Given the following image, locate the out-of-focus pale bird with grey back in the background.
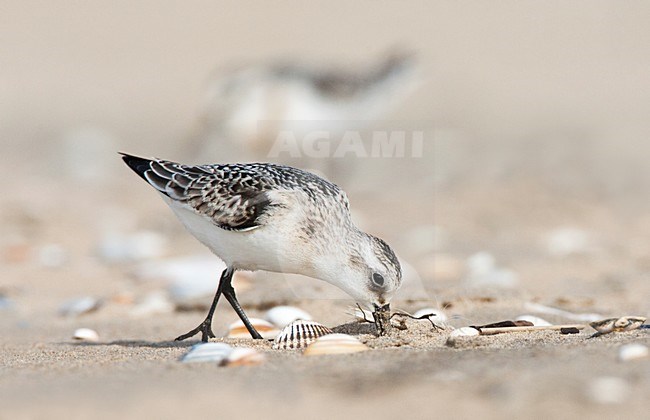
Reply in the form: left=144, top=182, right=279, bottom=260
left=192, top=50, right=418, bottom=157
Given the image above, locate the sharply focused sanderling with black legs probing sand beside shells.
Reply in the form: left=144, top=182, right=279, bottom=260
left=122, top=154, right=402, bottom=341
